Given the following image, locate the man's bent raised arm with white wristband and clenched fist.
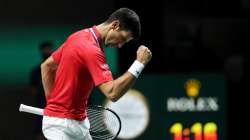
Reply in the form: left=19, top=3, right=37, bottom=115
left=99, top=46, right=152, bottom=102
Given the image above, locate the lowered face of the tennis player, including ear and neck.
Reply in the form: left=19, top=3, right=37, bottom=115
left=105, top=23, right=133, bottom=48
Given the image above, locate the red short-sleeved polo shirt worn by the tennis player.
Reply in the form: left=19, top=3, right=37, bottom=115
left=44, top=26, right=113, bottom=120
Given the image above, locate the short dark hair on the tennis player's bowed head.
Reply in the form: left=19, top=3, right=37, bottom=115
left=105, top=8, right=141, bottom=40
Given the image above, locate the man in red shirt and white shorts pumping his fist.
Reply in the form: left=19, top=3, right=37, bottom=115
left=41, top=8, right=152, bottom=140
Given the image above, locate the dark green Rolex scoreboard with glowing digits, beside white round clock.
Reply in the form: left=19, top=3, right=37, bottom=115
left=135, top=73, right=227, bottom=140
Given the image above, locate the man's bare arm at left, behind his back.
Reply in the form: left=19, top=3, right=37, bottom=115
left=41, top=65, right=56, bottom=96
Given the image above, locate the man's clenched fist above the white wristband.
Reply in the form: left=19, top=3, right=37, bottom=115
left=136, top=45, right=152, bottom=65
